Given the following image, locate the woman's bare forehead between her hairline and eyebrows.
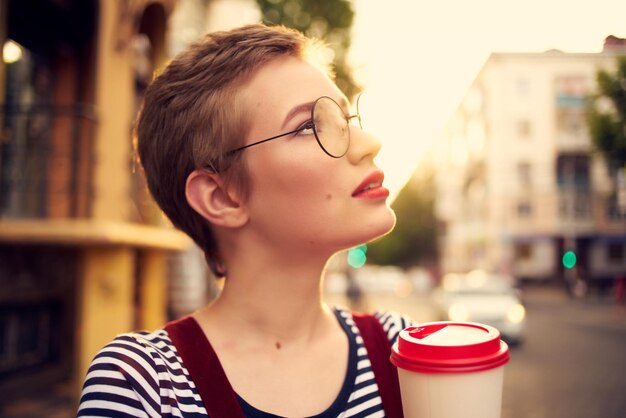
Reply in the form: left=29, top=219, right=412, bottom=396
left=241, top=56, right=345, bottom=122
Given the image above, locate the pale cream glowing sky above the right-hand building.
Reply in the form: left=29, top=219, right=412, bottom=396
left=350, top=0, right=626, bottom=196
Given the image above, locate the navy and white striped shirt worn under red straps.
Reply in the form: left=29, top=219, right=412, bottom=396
left=78, top=308, right=410, bottom=418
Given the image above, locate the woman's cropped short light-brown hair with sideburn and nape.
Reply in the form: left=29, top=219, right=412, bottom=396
left=136, top=24, right=316, bottom=276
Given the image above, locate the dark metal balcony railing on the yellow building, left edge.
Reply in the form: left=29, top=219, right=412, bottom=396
left=0, top=103, right=96, bottom=218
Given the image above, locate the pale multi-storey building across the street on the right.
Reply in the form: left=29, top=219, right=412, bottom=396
left=436, top=38, right=626, bottom=292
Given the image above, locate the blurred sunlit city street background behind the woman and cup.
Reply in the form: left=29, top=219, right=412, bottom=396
left=0, top=0, right=626, bottom=418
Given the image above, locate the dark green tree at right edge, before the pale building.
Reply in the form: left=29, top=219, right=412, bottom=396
left=588, top=57, right=626, bottom=167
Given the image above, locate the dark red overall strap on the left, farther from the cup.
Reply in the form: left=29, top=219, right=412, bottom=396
left=165, top=316, right=245, bottom=418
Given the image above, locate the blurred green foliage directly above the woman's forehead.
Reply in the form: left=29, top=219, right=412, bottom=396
left=257, top=0, right=359, bottom=98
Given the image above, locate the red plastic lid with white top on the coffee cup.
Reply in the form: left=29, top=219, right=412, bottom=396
left=391, top=322, right=509, bottom=373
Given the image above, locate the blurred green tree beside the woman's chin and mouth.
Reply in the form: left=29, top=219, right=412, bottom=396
left=367, top=170, right=438, bottom=267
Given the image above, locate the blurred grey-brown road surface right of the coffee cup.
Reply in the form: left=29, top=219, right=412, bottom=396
left=502, top=288, right=626, bottom=418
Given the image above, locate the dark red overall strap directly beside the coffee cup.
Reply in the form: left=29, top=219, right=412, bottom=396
left=352, top=312, right=404, bottom=418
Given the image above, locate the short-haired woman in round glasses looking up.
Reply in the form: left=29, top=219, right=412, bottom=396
left=79, top=25, right=408, bottom=418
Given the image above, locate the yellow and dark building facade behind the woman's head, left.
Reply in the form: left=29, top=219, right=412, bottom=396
left=0, top=0, right=190, bottom=406
